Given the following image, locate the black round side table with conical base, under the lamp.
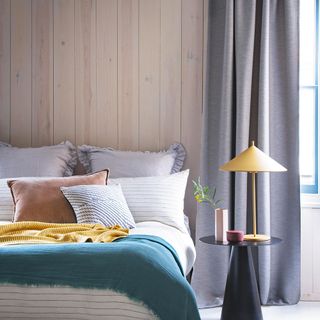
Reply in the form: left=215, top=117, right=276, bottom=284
left=200, top=236, right=282, bottom=320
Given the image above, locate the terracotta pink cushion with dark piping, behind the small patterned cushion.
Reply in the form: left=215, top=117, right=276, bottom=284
left=8, top=170, right=109, bottom=223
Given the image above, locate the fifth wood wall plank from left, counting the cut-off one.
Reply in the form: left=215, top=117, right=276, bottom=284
left=75, top=0, right=97, bottom=145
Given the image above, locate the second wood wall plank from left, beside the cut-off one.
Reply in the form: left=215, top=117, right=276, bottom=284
left=10, top=0, right=31, bottom=146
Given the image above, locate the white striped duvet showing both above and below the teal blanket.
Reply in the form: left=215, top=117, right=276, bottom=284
left=0, top=222, right=195, bottom=320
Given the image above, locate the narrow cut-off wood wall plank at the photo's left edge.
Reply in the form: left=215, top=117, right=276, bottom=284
left=0, top=0, right=11, bottom=142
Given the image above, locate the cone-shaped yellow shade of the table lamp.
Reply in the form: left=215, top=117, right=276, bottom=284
left=219, top=141, right=287, bottom=172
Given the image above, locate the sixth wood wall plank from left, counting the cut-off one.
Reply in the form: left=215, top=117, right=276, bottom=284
left=97, top=0, right=118, bottom=148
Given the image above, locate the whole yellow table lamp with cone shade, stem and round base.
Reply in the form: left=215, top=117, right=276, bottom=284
left=219, top=141, right=287, bottom=241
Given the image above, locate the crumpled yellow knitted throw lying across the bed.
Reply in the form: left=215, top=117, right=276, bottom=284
left=0, top=221, right=129, bottom=245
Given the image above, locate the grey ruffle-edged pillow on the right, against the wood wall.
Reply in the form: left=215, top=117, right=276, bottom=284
left=78, top=143, right=186, bottom=178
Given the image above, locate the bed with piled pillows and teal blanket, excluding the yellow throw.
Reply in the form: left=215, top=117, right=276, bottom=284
left=0, top=142, right=200, bottom=320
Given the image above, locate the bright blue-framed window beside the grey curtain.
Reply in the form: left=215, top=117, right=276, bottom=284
left=299, top=0, right=319, bottom=193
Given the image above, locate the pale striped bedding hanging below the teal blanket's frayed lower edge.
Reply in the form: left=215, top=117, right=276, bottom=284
left=0, top=284, right=157, bottom=320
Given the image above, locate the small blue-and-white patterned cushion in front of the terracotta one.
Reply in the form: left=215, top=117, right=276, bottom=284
left=60, top=185, right=135, bottom=228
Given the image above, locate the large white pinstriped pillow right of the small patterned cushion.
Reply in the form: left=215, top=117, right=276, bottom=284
left=108, top=170, right=189, bottom=230
